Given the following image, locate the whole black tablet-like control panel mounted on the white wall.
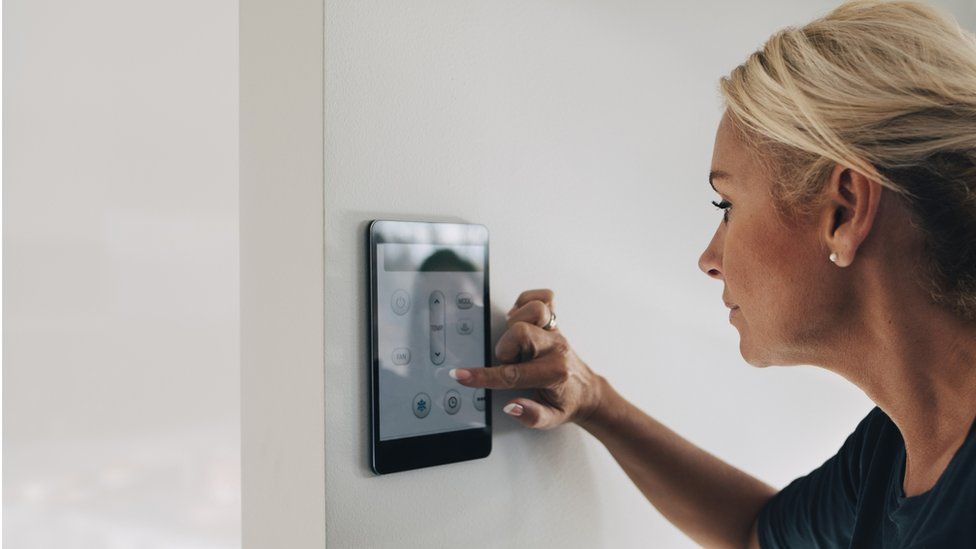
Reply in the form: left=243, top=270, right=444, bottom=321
left=368, top=220, right=491, bottom=474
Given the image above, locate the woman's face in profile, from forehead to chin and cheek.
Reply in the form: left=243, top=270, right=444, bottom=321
left=698, top=114, right=843, bottom=366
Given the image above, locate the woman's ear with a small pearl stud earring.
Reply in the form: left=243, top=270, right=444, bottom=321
left=822, top=164, right=884, bottom=267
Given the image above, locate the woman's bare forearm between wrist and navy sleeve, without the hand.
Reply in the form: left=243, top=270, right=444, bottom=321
left=576, top=376, right=776, bottom=548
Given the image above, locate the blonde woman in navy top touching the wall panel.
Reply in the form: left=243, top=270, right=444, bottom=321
left=452, top=1, right=976, bottom=547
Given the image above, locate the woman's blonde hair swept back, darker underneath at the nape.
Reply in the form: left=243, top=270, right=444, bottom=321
left=720, top=0, right=976, bottom=320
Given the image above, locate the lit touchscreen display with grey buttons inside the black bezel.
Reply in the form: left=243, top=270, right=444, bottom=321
left=376, top=243, right=487, bottom=440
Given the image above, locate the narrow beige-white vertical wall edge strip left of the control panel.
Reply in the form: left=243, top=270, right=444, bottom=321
left=240, top=0, right=325, bottom=549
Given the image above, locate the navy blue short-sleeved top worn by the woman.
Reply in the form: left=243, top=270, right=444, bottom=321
left=759, top=407, right=976, bottom=549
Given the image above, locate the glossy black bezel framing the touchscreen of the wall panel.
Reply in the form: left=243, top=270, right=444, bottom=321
left=366, top=219, right=492, bottom=475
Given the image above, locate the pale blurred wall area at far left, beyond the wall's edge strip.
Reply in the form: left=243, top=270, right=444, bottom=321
left=3, top=0, right=241, bottom=549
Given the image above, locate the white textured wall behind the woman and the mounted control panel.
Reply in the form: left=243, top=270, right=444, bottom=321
left=325, top=0, right=972, bottom=548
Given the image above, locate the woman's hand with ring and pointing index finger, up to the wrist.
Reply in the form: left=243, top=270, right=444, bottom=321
left=451, top=290, right=603, bottom=429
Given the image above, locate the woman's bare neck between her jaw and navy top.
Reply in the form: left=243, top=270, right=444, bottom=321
left=825, top=288, right=976, bottom=496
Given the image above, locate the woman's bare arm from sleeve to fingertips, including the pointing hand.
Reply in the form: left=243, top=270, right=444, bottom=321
left=458, top=289, right=776, bottom=548
